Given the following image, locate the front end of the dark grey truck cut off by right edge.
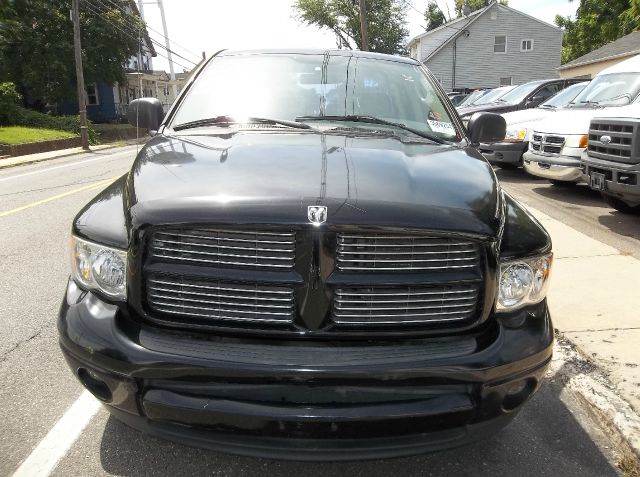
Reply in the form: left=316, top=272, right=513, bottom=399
left=582, top=118, right=640, bottom=213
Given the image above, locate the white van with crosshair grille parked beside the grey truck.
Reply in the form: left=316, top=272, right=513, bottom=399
left=523, top=55, right=640, bottom=185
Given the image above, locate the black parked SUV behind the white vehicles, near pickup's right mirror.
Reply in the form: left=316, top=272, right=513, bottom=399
left=458, top=79, right=583, bottom=120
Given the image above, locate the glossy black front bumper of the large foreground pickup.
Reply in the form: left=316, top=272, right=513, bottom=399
left=58, top=281, right=553, bottom=460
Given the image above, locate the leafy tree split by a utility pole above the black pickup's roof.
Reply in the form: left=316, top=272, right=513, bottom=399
left=294, top=0, right=409, bottom=54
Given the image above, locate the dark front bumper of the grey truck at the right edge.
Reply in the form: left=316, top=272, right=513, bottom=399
left=582, top=157, right=640, bottom=206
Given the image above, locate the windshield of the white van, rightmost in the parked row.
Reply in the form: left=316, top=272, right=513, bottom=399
left=571, top=73, right=640, bottom=107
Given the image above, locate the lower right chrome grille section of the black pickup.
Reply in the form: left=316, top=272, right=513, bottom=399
left=332, top=283, right=480, bottom=326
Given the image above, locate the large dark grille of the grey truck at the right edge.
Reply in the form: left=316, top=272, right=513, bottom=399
left=587, top=119, right=640, bottom=164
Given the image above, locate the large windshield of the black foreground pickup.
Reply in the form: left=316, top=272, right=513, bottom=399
left=172, top=53, right=459, bottom=140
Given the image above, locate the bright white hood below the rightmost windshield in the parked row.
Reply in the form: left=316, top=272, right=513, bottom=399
left=533, top=104, right=640, bottom=136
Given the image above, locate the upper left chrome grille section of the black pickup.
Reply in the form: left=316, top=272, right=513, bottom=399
left=151, top=228, right=295, bottom=270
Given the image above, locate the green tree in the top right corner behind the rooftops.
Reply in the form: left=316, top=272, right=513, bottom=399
left=555, top=0, right=640, bottom=63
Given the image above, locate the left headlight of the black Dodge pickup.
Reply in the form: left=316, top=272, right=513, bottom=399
left=71, top=236, right=127, bottom=300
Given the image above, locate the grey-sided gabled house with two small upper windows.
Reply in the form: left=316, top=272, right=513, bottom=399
left=408, top=2, right=562, bottom=91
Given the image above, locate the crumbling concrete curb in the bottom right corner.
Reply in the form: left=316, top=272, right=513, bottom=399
left=549, top=330, right=640, bottom=477
